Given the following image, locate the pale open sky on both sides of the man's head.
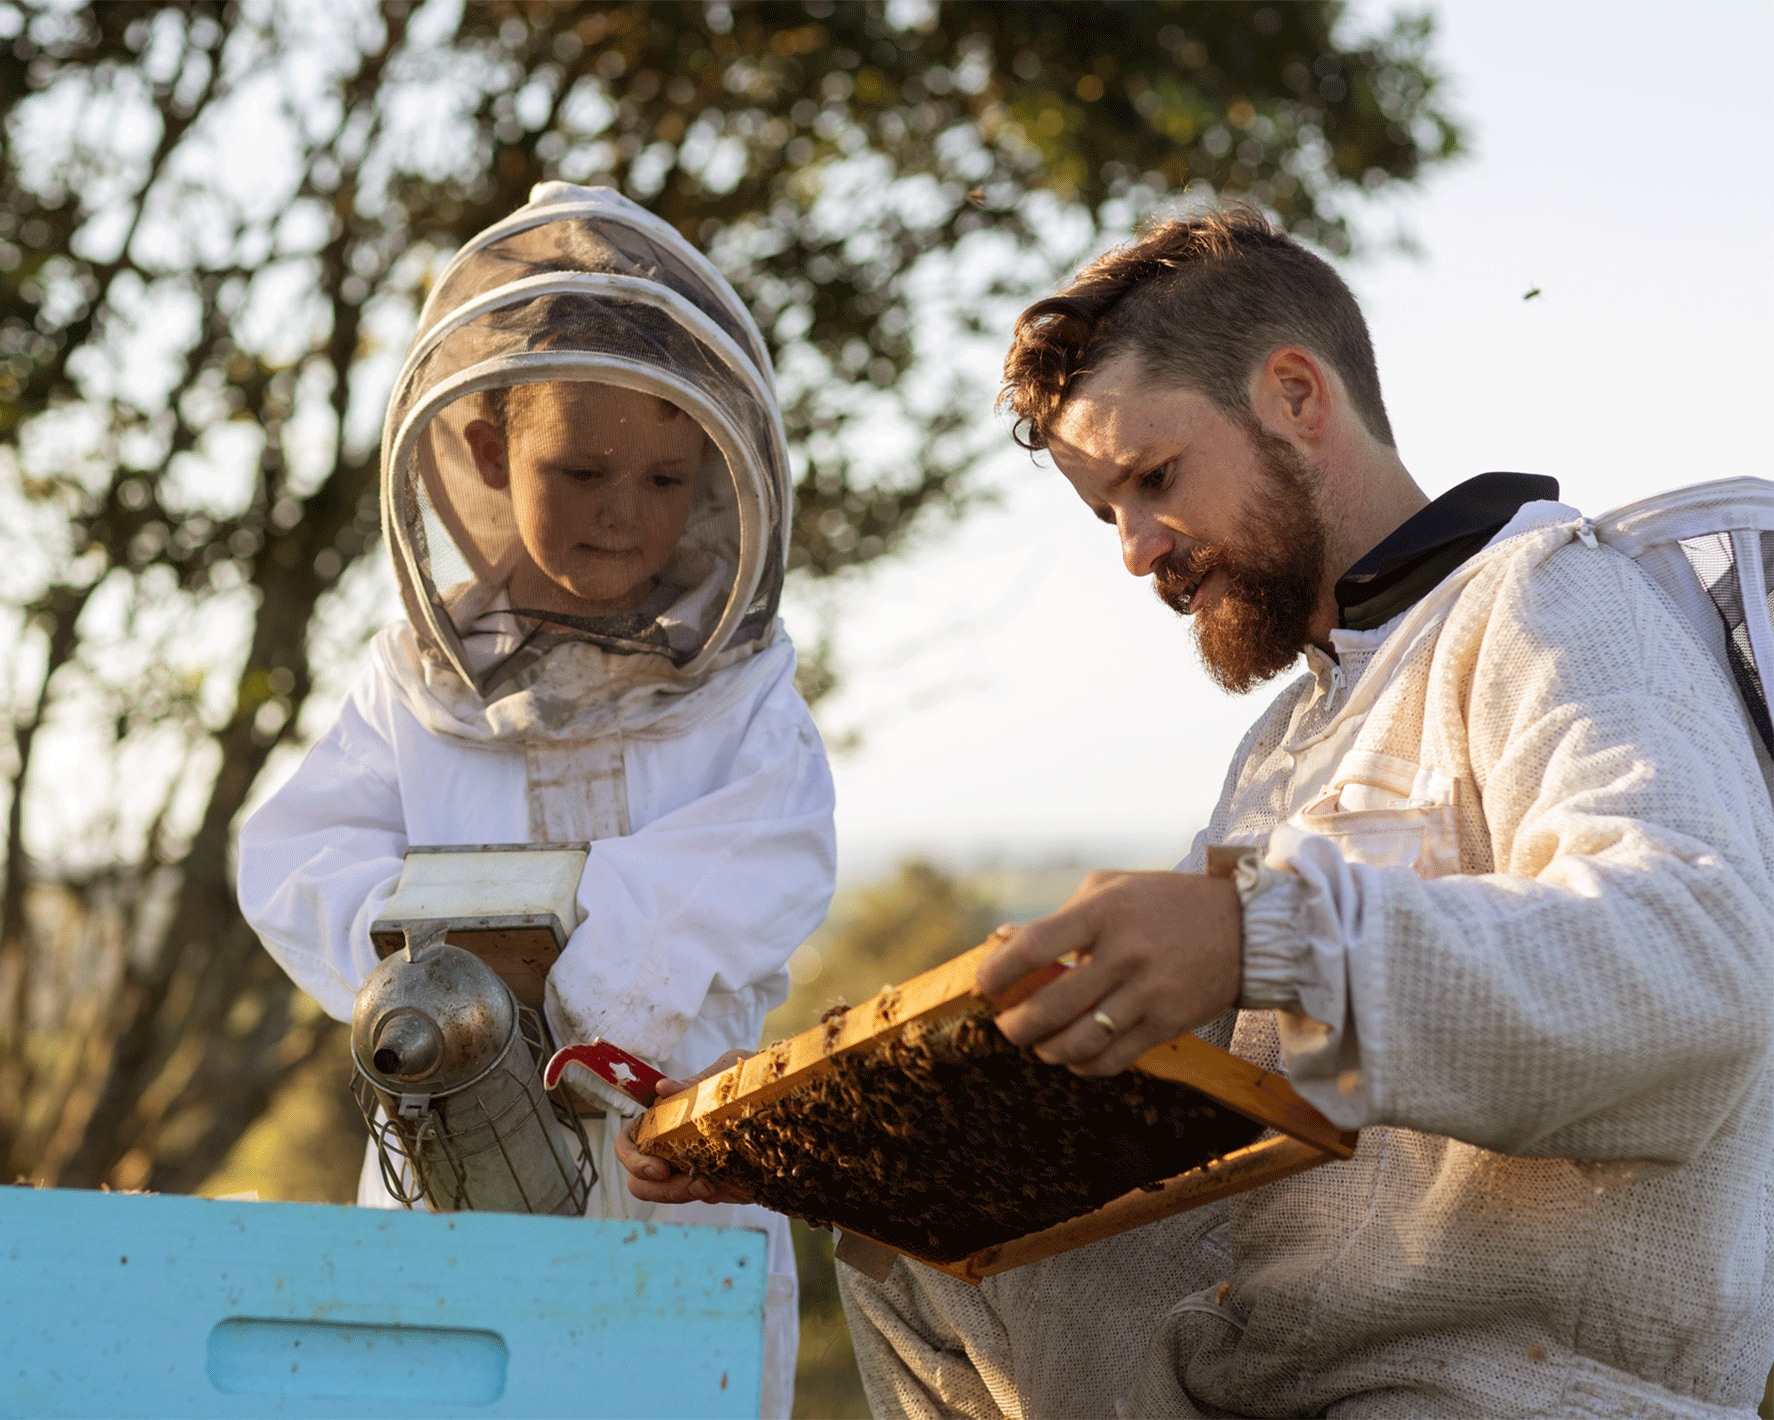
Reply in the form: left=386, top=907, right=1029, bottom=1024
left=805, top=0, right=1774, bottom=879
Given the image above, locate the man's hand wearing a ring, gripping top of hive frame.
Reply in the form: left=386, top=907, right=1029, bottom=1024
left=979, top=873, right=1244, bottom=1076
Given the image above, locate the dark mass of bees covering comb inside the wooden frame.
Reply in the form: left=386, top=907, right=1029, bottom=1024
left=676, top=1010, right=1263, bottom=1262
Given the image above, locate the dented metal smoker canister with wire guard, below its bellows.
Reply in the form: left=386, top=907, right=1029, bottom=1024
left=351, top=927, right=598, bottom=1216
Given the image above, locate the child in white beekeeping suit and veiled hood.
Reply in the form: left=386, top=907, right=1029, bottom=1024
left=239, top=183, right=836, bottom=1415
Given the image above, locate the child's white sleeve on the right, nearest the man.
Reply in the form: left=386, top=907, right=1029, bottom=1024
left=548, top=678, right=837, bottom=1061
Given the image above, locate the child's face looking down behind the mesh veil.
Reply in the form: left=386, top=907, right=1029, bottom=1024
left=467, top=382, right=704, bottom=616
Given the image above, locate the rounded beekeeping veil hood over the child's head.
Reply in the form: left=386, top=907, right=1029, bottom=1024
left=381, top=183, right=789, bottom=703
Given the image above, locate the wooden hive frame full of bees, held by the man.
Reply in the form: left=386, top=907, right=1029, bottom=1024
left=635, top=937, right=1355, bottom=1282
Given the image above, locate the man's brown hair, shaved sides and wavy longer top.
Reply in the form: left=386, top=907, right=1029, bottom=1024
left=999, top=206, right=1393, bottom=449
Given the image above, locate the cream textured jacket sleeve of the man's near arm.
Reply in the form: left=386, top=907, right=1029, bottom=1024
left=1245, top=559, right=1774, bottom=1163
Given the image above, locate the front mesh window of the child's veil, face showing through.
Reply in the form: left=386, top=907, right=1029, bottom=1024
left=404, top=380, right=740, bottom=683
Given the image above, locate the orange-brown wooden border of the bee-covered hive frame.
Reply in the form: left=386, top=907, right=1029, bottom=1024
left=635, top=861, right=1357, bottom=1283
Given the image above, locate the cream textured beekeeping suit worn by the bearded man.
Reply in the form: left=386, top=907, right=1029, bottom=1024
left=839, top=479, right=1774, bottom=1420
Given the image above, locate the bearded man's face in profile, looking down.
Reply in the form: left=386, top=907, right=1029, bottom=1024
left=1048, top=355, right=1325, bottom=692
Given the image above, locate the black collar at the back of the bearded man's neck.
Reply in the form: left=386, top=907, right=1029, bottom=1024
left=1336, top=474, right=1558, bottom=630
